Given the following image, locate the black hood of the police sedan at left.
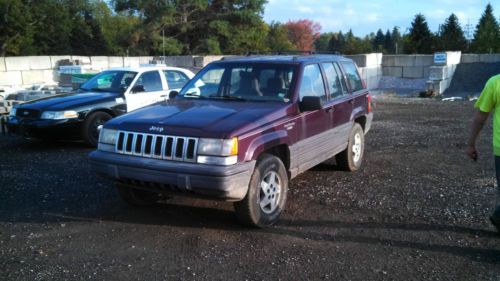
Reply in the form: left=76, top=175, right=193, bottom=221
left=19, top=92, right=120, bottom=110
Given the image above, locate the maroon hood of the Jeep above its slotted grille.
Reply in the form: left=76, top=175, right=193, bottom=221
left=106, top=99, right=290, bottom=138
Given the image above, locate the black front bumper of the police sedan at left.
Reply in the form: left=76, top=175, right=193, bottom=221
left=7, top=117, right=83, bottom=139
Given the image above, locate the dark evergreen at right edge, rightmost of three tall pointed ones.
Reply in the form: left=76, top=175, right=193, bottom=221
left=471, top=4, right=500, bottom=53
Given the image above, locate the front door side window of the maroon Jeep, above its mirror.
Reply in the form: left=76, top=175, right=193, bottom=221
left=299, top=64, right=326, bottom=101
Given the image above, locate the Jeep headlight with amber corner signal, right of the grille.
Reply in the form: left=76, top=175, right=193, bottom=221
left=197, top=137, right=238, bottom=166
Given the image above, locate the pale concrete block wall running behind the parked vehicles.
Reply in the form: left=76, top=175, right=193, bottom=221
left=0, top=53, right=500, bottom=89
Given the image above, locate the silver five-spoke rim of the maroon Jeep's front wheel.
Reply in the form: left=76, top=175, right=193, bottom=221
left=259, top=171, right=281, bottom=214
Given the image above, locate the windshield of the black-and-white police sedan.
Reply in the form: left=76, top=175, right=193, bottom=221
left=80, top=70, right=137, bottom=93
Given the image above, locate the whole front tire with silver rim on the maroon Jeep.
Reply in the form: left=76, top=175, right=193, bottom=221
left=234, top=154, right=288, bottom=227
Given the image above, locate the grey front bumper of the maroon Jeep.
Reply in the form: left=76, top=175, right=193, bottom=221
left=89, top=150, right=255, bottom=201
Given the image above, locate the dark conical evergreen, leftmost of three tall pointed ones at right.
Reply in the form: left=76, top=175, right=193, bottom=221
left=404, top=14, right=434, bottom=54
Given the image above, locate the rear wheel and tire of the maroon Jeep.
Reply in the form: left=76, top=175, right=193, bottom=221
left=335, top=123, right=365, bottom=172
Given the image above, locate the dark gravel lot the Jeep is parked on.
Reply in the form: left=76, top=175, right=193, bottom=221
left=0, top=99, right=500, bottom=280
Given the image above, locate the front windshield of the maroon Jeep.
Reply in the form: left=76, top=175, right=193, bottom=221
left=179, top=63, right=296, bottom=103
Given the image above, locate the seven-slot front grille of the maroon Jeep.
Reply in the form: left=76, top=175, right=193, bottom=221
left=115, top=131, right=198, bottom=162
